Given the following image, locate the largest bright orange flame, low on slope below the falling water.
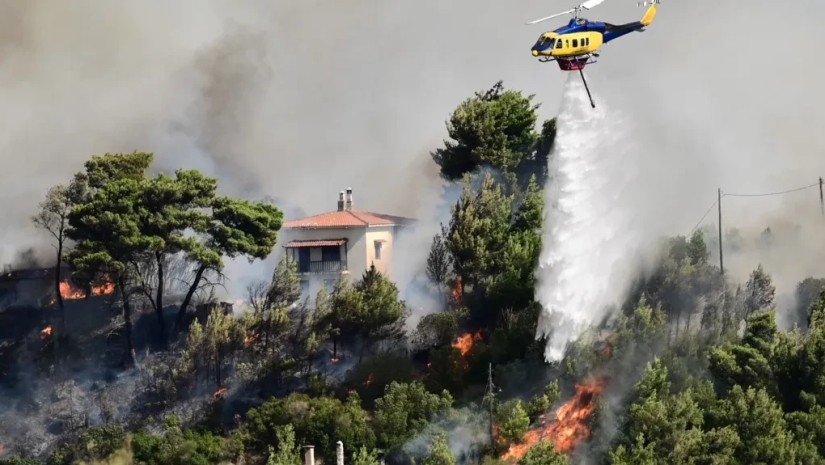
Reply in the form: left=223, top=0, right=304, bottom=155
left=502, top=378, right=606, bottom=461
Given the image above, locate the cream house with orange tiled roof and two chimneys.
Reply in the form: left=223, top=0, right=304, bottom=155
left=282, top=188, right=415, bottom=298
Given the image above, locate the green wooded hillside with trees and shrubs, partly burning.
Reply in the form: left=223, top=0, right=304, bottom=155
left=0, top=83, right=825, bottom=465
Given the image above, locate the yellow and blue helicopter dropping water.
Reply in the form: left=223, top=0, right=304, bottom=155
left=527, top=0, right=662, bottom=108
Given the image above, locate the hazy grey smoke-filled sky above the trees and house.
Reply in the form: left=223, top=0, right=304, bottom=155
left=0, top=0, right=825, bottom=296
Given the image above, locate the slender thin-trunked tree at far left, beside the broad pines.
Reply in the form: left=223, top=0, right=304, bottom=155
left=32, top=181, right=82, bottom=332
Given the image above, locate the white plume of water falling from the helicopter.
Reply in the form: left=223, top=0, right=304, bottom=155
left=536, top=73, right=643, bottom=362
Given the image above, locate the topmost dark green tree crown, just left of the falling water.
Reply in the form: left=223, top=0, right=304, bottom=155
left=431, top=81, right=539, bottom=180
